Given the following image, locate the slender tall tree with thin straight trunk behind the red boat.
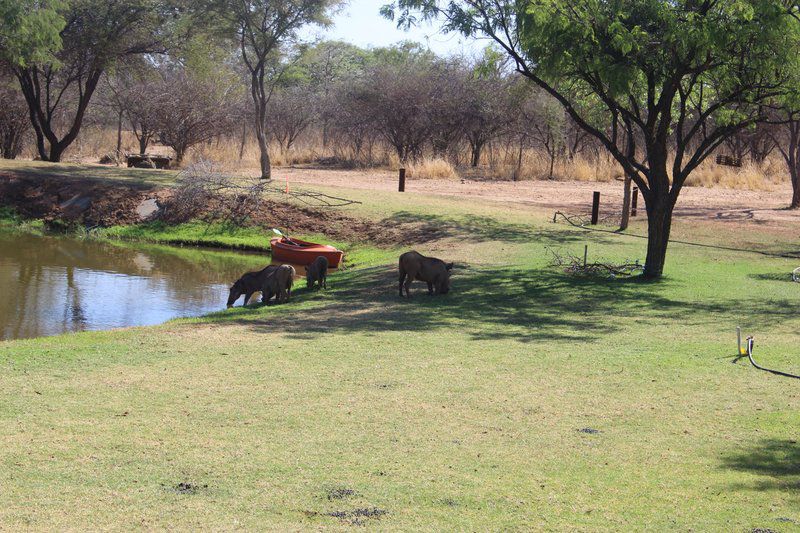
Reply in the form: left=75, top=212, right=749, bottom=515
left=211, top=0, right=339, bottom=179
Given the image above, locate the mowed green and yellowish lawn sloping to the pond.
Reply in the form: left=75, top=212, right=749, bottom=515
left=0, top=162, right=800, bottom=531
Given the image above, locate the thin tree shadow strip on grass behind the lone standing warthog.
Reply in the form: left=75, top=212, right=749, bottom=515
left=380, top=211, right=616, bottom=245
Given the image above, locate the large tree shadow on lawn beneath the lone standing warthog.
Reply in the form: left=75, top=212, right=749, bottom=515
left=209, top=267, right=795, bottom=342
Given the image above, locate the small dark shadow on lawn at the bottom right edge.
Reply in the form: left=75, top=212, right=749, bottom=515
left=722, top=439, right=800, bottom=497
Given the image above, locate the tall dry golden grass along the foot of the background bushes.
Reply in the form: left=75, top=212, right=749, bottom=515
left=29, top=125, right=787, bottom=191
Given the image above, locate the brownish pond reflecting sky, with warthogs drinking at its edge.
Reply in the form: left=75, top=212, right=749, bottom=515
left=0, top=232, right=269, bottom=340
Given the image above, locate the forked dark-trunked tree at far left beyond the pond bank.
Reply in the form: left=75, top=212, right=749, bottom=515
left=0, top=0, right=177, bottom=161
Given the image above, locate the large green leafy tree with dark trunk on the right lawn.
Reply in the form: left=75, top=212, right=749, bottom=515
left=382, top=0, right=800, bottom=278
